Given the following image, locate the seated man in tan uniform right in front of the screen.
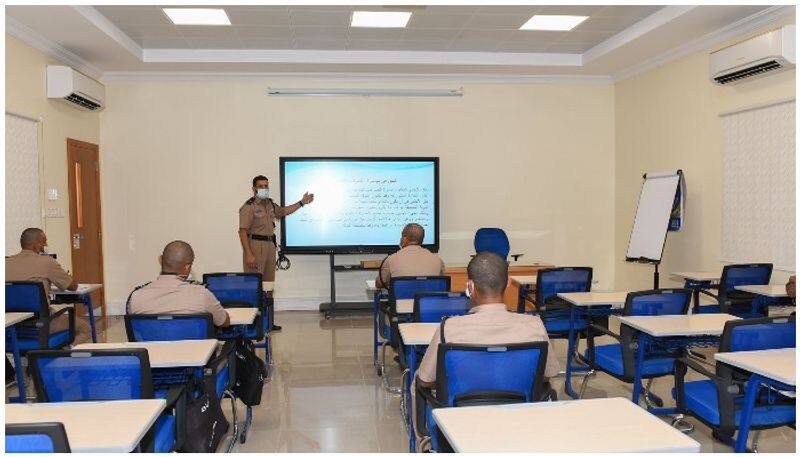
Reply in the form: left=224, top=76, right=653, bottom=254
left=375, top=223, right=444, bottom=288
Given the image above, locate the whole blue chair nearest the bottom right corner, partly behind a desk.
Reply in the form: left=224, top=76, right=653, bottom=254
left=672, top=315, right=797, bottom=447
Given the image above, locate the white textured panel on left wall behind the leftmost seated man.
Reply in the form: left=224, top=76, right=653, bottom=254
left=6, top=114, right=42, bottom=255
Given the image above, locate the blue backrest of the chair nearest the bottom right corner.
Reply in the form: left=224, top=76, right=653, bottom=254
left=719, top=316, right=797, bottom=352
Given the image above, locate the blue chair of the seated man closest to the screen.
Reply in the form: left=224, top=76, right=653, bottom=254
left=378, top=276, right=450, bottom=391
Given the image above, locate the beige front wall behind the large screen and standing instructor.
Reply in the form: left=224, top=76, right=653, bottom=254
left=101, top=80, right=614, bottom=312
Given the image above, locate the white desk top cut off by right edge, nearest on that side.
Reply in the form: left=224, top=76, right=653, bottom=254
left=714, top=348, right=797, bottom=386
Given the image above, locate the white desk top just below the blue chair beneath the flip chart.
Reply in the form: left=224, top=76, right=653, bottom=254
left=619, top=314, right=739, bottom=337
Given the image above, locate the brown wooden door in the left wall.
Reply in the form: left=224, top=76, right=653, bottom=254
left=67, top=138, right=106, bottom=323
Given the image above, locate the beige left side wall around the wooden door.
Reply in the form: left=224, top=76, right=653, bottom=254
left=6, top=34, right=104, bottom=268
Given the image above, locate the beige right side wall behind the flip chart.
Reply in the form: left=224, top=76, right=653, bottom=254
left=614, top=19, right=795, bottom=290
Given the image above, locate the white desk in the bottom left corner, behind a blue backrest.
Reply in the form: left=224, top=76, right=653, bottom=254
left=6, top=398, right=167, bottom=453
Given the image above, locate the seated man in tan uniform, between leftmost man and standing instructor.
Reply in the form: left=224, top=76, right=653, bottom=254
left=127, top=241, right=231, bottom=327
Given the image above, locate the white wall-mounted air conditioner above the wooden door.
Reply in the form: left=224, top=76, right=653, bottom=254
left=47, top=65, right=106, bottom=111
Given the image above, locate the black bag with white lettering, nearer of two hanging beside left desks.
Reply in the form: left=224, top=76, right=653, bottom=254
left=181, top=377, right=230, bottom=453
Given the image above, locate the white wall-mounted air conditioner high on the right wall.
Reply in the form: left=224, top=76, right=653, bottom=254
left=709, top=25, right=795, bottom=85
